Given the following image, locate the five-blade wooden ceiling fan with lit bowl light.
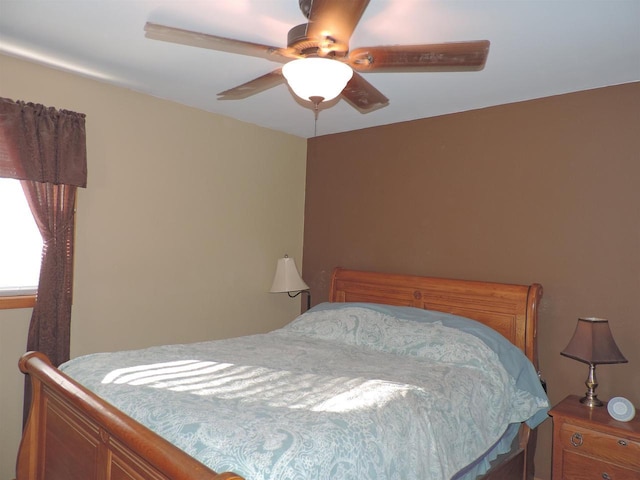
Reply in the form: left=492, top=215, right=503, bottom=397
left=144, top=0, right=489, bottom=113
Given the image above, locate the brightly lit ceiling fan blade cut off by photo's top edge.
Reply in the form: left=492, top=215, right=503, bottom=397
left=300, top=0, right=369, bottom=52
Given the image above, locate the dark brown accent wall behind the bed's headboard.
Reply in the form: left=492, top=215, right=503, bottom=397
left=304, top=83, right=640, bottom=479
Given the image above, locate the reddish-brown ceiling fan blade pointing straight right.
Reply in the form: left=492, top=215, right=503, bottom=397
left=349, top=40, right=489, bottom=72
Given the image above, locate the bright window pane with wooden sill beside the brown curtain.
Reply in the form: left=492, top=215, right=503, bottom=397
left=0, top=178, right=42, bottom=308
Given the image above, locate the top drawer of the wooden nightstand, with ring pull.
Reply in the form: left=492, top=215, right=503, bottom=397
left=560, top=423, right=640, bottom=468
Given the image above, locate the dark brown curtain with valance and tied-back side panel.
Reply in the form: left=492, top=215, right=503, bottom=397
left=0, top=98, right=87, bottom=419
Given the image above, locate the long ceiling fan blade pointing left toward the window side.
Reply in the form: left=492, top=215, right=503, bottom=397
left=144, top=22, right=299, bottom=63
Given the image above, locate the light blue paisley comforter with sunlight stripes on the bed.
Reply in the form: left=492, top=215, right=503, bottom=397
left=61, top=304, right=548, bottom=480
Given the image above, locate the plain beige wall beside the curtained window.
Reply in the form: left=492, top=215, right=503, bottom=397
left=0, top=56, right=306, bottom=480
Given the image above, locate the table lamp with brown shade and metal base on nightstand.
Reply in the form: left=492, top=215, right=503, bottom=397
left=560, top=318, right=628, bottom=407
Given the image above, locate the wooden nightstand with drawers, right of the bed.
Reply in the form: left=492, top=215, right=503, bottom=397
left=549, top=395, right=640, bottom=480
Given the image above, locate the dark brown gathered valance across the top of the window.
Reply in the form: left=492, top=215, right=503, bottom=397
left=0, top=97, right=87, bottom=187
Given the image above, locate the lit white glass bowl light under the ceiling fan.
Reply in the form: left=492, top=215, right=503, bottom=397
left=282, top=57, right=353, bottom=102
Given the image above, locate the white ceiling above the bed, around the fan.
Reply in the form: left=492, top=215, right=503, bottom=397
left=0, top=0, right=640, bottom=138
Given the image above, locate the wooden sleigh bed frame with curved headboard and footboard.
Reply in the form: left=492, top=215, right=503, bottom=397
left=16, top=268, right=542, bottom=480
